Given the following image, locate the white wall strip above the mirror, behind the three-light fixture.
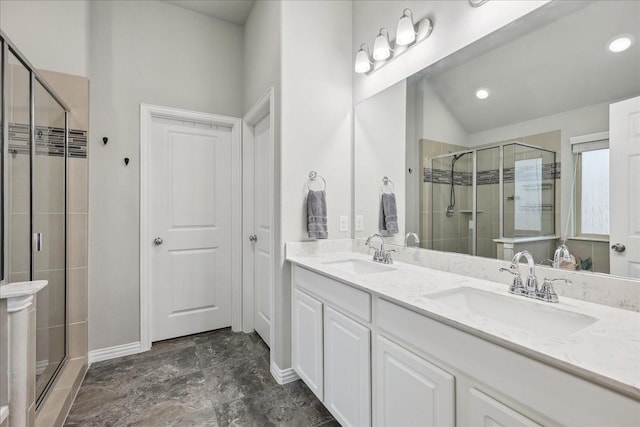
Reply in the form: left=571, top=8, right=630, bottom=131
left=350, top=0, right=549, bottom=104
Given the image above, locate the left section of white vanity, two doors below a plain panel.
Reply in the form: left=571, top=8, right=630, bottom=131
left=292, top=267, right=371, bottom=427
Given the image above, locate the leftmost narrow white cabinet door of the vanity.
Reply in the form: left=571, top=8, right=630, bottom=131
left=291, top=289, right=323, bottom=400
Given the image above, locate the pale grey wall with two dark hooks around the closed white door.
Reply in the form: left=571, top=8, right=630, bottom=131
left=89, top=0, right=243, bottom=350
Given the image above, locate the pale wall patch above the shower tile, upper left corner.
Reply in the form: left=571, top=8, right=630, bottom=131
left=0, top=0, right=89, bottom=77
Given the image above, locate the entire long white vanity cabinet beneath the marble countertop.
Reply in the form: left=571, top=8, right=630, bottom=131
left=292, top=265, right=640, bottom=427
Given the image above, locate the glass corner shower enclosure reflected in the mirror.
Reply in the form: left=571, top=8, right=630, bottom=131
left=421, top=143, right=556, bottom=258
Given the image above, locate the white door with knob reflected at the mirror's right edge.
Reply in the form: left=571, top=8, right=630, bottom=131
left=609, top=97, right=640, bottom=278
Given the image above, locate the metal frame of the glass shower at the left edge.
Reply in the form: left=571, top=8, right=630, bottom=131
left=0, top=30, right=71, bottom=410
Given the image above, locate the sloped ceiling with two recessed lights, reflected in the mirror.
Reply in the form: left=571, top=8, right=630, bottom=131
left=416, top=1, right=640, bottom=134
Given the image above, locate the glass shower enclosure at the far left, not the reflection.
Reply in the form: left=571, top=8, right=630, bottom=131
left=0, top=32, right=69, bottom=405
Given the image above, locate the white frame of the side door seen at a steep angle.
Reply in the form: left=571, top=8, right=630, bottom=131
left=242, top=87, right=276, bottom=346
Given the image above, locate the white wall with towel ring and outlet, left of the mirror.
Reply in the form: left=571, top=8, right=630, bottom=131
left=272, top=1, right=353, bottom=368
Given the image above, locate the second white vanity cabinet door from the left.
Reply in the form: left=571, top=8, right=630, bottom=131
left=324, top=307, right=371, bottom=427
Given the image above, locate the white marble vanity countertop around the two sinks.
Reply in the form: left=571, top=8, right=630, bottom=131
left=287, top=250, right=640, bottom=400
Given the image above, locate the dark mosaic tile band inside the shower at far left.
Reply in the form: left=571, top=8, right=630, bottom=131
left=9, top=123, right=87, bottom=159
